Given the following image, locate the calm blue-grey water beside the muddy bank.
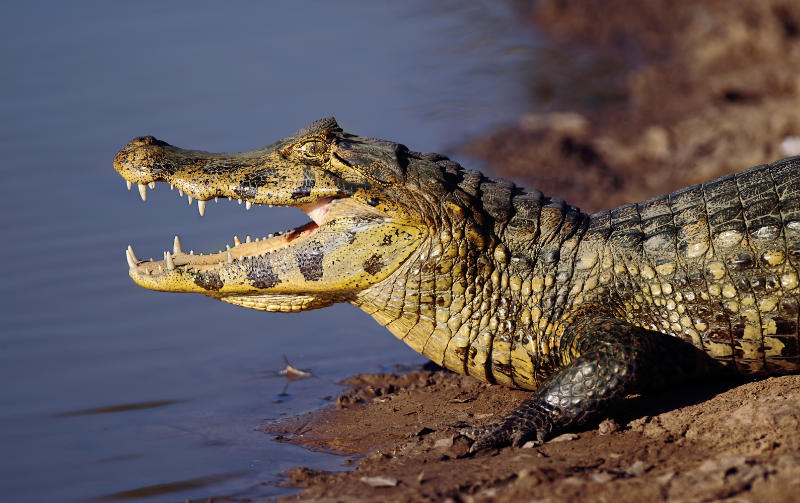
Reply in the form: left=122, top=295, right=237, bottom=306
left=0, top=0, right=544, bottom=502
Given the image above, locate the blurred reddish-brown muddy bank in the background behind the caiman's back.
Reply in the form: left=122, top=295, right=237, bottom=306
left=465, top=0, right=800, bottom=212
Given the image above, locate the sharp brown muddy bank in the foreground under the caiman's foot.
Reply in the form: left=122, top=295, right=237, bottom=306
left=267, top=371, right=800, bottom=502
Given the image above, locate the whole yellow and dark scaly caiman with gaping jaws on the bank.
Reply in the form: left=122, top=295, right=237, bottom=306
left=114, top=118, right=800, bottom=450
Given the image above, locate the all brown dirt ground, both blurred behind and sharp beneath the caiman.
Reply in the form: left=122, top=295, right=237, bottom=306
left=267, top=0, right=800, bottom=502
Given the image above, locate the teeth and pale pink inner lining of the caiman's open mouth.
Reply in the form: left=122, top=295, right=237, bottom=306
left=125, top=180, right=336, bottom=275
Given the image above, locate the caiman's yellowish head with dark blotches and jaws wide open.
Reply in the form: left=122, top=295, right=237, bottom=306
left=114, top=118, right=476, bottom=312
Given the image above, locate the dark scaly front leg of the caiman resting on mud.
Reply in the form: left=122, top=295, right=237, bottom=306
left=462, top=318, right=720, bottom=452
